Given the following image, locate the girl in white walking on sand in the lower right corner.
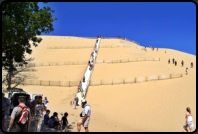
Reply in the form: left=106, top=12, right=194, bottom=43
left=183, top=107, right=194, bottom=132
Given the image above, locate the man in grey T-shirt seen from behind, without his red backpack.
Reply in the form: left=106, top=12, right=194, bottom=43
left=7, top=95, right=31, bottom=132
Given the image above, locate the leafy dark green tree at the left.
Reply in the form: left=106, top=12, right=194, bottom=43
left=2, top=2, right=57, bottom=89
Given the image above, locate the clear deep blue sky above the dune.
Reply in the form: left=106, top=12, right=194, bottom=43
left=38, top=2, right=196, bottom=55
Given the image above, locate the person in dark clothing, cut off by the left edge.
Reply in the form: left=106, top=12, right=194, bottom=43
left=2, top=93, right=11, bottom=132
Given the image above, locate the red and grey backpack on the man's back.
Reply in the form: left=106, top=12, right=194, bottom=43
left=15, top=105, right=30, bottom=125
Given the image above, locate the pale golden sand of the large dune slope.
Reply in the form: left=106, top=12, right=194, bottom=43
left=2, top=36, right=196, bottom=132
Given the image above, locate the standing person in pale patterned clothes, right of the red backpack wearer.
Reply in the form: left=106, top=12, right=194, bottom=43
left=34, top=98, right=44, bottom=132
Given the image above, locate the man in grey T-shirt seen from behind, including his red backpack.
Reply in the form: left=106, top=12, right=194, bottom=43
left=7, top=95, right=31, bottom=132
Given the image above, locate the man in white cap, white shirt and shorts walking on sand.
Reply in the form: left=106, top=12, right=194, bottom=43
left=77, top=99, right=91, bottom=132
